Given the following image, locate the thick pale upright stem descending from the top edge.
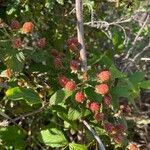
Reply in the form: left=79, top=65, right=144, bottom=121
left=75, top=0, right=87, bottom=73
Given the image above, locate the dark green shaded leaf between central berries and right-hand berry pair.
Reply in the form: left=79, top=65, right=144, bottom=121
left=85, top=87, right=102, bottom=103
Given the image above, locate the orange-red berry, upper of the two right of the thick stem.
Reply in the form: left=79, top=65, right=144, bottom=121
left=97, top=71, right=111, bottom=82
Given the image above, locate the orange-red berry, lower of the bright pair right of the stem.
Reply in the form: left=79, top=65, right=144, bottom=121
left=95, top=84, right=109, bottom=95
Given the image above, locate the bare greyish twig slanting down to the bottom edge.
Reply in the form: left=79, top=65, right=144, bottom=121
left=83, top=120, right=105, bottom=150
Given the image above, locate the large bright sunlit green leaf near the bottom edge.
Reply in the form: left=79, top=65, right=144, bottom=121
left=38, top=128, right=68, bottom=147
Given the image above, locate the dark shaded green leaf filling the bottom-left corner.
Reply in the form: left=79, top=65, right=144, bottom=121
left=0, top=126, right=26, bottom=150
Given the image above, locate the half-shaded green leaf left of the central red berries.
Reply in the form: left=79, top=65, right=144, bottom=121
left=50, top=89, right=72, bottom=105
